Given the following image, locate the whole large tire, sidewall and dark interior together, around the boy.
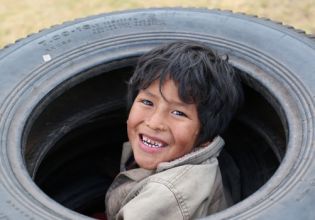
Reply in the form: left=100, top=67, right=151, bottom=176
left=0, top=9, right=315, bottom=220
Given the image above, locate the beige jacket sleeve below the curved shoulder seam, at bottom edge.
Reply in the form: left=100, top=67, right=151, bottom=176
left=116, top=182, right=189, bottom=220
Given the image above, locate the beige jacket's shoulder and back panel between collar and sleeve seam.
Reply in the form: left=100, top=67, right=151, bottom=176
left=145, top=161, right=222, bottom=218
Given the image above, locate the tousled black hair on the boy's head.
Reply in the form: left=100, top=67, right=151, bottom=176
left=127, top=41, right=243, bottom=146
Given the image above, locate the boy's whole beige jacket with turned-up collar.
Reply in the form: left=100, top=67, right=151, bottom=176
left=105, top=137, right=227, bottom=220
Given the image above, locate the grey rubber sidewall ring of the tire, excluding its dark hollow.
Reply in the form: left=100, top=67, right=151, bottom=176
left=0, top=8, right=315, bottom=219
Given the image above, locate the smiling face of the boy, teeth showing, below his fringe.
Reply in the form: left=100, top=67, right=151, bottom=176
left=127, top=79, right=200, bottom=169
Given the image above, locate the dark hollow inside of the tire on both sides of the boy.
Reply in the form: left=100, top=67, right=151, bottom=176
left=23, top=61, right=286, bottom=217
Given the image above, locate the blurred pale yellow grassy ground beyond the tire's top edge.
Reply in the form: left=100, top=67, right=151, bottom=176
left=0, top=0, right=315, bottom=48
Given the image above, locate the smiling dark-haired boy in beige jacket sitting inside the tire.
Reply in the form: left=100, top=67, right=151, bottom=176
left=105, top=41, right=242, bottom=219
